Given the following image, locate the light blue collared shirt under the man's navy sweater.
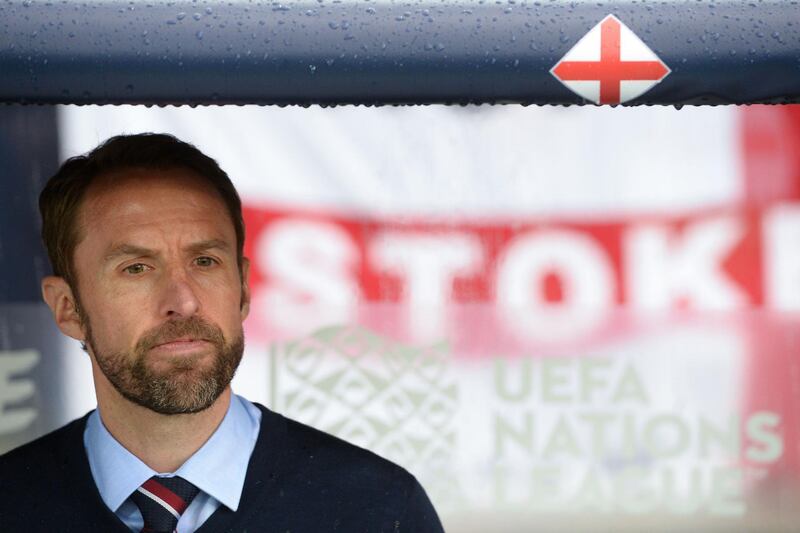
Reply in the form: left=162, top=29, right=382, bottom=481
left=83, top=394, right=261, bottom=533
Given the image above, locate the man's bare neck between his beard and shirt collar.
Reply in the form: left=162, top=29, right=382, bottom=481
left=95, top=366, right=231, bottom=473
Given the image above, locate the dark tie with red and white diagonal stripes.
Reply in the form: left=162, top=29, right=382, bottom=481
left=131, top=476, right=200, bottom=533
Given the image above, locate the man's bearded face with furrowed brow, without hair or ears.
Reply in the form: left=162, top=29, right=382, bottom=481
left=73, top=169, right=248, bottom=414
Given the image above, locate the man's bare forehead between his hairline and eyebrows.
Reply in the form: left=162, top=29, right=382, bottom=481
left=78, top=169, right=234, bottom=240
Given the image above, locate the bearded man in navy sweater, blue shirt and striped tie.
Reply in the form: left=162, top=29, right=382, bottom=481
left=0, top=134, right=442, bottom=533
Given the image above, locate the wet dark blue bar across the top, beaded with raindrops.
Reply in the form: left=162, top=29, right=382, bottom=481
left=0, top=0, right=800, bottom=105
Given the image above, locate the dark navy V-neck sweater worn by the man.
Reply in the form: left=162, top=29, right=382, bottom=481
left=0, top=405, right=442, bottom=533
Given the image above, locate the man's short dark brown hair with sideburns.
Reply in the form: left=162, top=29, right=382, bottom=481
left=39, top=133, right=244, bottom=289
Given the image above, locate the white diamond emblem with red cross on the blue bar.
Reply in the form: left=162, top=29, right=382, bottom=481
left=550, top=15, right=670, bottom=104
